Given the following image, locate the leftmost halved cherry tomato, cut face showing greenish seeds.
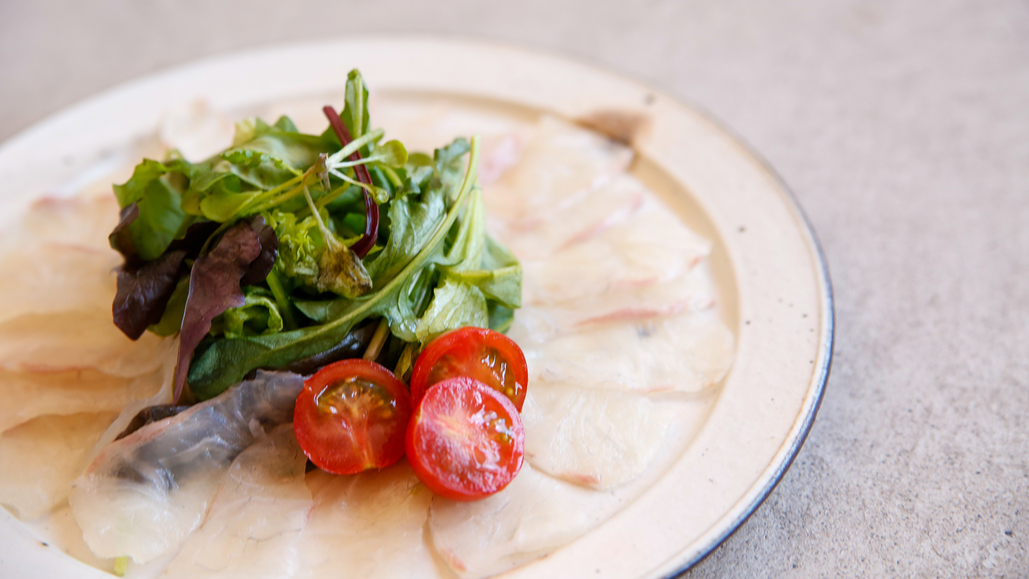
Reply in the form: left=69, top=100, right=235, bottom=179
left=293, top=358, right=411, bottom=474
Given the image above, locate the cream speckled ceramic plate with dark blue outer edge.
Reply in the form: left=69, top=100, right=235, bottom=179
left=0, top=37, right=832, bottom=578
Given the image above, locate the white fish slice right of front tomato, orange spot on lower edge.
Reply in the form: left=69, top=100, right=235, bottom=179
left=522, top=382, right=673, bottom=490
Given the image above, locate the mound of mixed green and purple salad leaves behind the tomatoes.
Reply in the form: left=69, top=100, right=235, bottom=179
left=110, top=70, right=522, bottom=400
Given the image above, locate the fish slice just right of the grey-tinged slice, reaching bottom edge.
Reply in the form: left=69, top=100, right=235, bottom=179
left=164, top=424, right=313, bottom=579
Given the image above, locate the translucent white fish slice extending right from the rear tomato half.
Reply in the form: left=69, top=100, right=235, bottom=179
left=509, top=310, right=735, bottom=392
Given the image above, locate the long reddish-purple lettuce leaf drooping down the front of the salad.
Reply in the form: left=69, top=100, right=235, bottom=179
left=174, top=216, right=278, bottom=401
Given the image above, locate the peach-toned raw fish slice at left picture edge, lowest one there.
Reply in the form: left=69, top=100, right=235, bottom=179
left=0, top=412, right=117, bottom=519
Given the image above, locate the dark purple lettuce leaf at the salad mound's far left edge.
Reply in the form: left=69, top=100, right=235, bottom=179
left=111, top=250, right=186, bottom=339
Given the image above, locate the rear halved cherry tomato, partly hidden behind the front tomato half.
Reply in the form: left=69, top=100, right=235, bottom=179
left=411, top=327, right=529, bottom=412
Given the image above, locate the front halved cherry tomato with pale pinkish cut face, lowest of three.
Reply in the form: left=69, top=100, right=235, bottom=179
left=406, top=377, right=525, bottom=501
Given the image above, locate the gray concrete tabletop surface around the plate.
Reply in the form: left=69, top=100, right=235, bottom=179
left=0, top=0, right=1029, bottom=579
